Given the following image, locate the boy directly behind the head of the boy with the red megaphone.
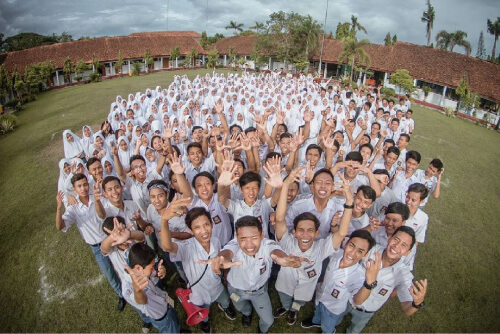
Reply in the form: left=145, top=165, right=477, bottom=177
left=190, top=172, right=232, bottom=246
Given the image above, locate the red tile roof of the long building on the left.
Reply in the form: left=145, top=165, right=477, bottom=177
left=0, top=32, right=205, bottom=73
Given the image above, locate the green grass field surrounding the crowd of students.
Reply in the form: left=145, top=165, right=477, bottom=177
left=0, top=71, right=500, bottom=332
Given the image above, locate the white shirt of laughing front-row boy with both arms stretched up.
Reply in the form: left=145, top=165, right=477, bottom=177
left=276, top=231, right=335, bottom=301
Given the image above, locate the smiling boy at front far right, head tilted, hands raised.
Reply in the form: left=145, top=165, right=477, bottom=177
left=347, top=226, right=427, bottom=333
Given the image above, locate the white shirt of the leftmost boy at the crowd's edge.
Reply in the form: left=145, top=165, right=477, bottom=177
left=62, top=197, right=106, bottom=245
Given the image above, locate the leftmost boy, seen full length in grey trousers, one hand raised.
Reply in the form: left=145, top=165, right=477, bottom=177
left=56, top=174, right=126, bottom=311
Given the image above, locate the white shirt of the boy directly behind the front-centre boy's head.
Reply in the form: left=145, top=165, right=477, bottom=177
left=226, top=198, right=274, bottom=238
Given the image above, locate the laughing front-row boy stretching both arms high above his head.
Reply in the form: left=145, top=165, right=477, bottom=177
left=273, top=167, right=353, bottom=326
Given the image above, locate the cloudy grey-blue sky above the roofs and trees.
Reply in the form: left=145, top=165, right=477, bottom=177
left=0, top=0, right=500, bottom=56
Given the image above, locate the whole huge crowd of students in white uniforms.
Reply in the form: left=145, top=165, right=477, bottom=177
left=56, top=72, right=444, bottom=333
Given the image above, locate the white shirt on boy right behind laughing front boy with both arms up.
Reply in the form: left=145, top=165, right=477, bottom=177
left=285, top=195, right=344, bottom=239
